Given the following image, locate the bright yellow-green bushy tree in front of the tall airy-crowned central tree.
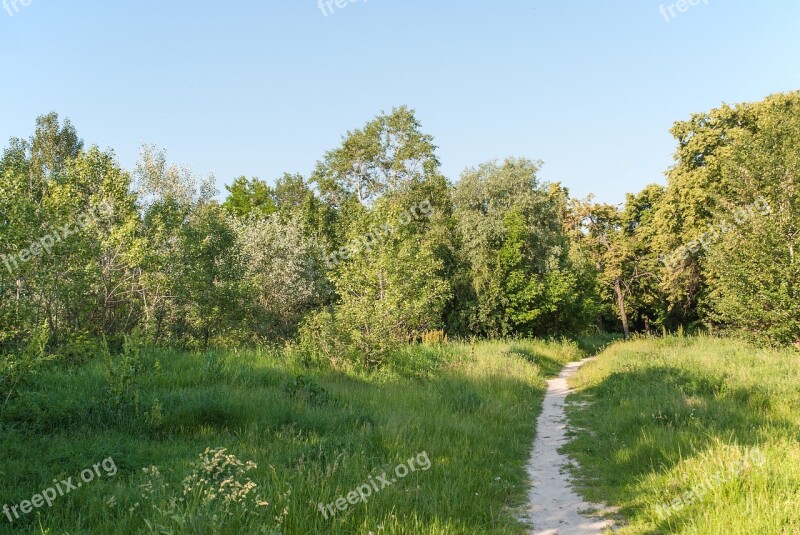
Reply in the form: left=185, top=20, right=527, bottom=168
left=304, top=196, right=450, bottom=367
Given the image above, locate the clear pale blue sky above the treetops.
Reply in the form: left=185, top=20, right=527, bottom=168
left=0, top=0, right=800, bottom=203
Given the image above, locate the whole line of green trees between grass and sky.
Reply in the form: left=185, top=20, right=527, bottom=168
left=0, top=92, right=800, bottom=366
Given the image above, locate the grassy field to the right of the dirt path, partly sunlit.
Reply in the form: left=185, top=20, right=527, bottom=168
left=567, top=337, right=800, bottom=535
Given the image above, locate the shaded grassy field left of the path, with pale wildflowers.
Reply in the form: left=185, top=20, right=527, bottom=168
left=0, top=341, right=582, bottom=535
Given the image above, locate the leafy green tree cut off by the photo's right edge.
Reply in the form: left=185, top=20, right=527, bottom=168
left=708, top=92, right=800, bottom=343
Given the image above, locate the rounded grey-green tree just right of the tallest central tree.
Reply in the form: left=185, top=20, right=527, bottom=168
left=453, top=159, right=580, bottom=335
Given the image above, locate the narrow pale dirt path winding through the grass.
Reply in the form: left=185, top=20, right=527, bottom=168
left=525, top=359, right=611, bottom=535
